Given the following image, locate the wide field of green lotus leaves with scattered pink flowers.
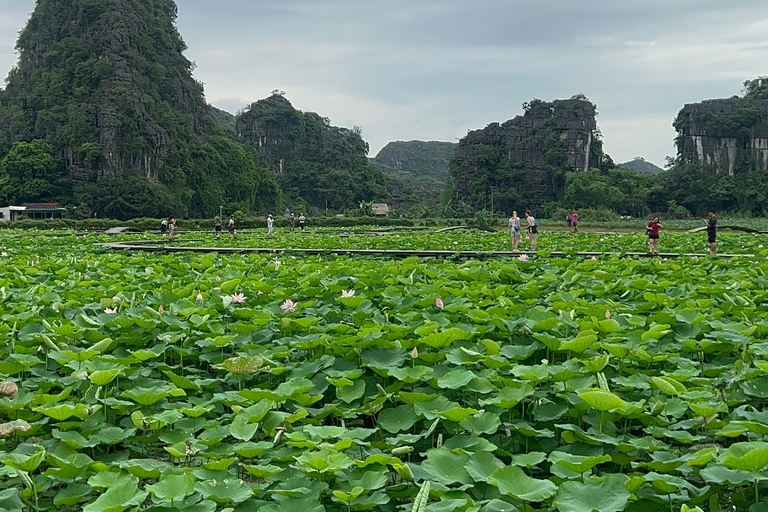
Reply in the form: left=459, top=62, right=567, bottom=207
left=0, top=232, right=768, bottom=512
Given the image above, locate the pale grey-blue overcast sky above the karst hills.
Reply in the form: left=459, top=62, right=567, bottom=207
left=0, top=0, right=768, bottom=165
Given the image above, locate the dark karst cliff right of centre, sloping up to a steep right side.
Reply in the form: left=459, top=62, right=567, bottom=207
left=451, top=98, right=610, bottom=210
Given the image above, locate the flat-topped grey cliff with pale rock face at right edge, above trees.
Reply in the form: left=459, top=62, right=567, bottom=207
left=675, top=96, right=768, bottom=176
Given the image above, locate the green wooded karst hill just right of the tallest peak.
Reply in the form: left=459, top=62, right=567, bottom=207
left=236, top=93, right=387, bottom=209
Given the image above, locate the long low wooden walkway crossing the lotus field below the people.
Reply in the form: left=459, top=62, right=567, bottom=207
left=103, top=240, right=755, bottom=259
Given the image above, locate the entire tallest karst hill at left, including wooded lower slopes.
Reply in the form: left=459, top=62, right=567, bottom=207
left=0, top=0, right=279, bottom=218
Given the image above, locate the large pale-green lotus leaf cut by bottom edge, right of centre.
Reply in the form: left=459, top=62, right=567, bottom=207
left=555, top=475, right=631, bottom=512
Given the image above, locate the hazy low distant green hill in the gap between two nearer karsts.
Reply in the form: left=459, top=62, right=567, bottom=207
left=371, top=140, right=456, bottom=206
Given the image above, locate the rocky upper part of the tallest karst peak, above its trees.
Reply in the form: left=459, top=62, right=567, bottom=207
left=0, top=0, right=214, bottom=181
